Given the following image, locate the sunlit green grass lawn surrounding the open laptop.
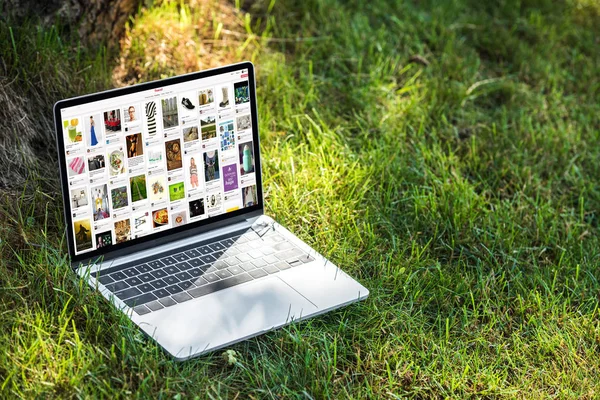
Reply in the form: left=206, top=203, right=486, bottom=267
left=0, top=0, right=600, bottom=398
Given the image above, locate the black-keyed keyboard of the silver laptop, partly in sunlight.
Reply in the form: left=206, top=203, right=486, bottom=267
left=96, top=229, right=314, bottom=315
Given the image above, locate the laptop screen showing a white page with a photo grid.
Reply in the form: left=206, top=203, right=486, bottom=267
left=55, top=64, right=262, bottom=258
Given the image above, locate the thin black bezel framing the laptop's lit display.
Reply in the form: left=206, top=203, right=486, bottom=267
left=54, top=61, right=264, bottom=264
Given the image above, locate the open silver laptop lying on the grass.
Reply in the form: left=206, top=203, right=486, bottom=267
left=54, top=62, right=369, bottom=360
